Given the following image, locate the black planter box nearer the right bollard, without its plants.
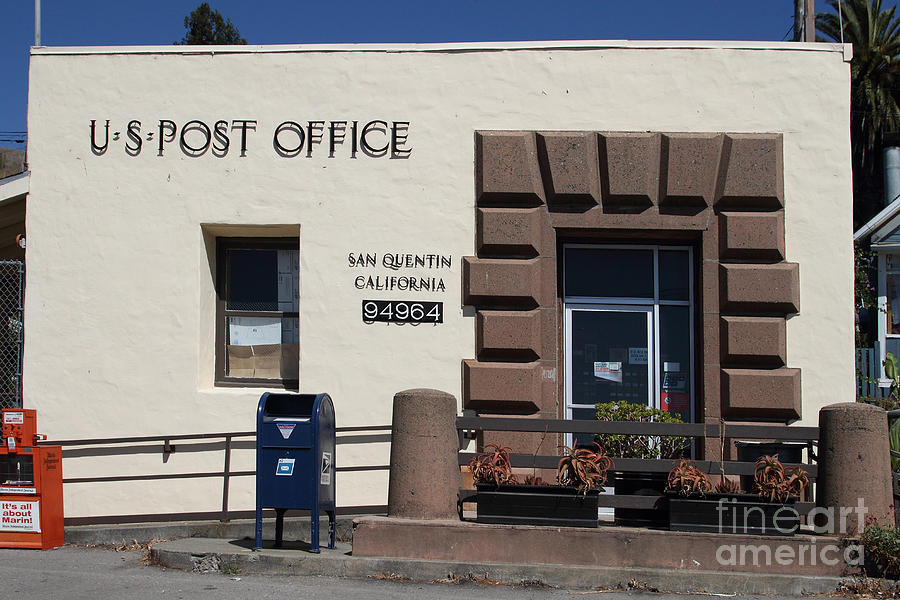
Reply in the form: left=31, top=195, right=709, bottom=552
left=669, top=494, right=800, bottom=535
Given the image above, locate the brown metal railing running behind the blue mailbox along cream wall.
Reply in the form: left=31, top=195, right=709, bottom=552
left=39, top=425, right=391, bottom=524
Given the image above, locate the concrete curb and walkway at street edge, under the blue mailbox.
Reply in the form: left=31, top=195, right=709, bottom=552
left=66, top=517, right=841, bottom=596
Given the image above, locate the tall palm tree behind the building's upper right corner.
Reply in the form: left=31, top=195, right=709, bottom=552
left=816, top=0, right=900, bottom=180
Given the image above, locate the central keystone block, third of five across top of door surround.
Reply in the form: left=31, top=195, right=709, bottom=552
left=598, top=133, right=661, bottom=208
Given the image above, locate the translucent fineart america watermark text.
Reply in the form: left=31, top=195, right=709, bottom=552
left=716, top=498, right=868, bottom=567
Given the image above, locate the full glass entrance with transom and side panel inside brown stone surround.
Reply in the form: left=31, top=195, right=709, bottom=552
left=563, top=244, right=694, bottom=432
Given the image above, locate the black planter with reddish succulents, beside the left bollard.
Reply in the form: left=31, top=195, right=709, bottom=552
left=469, top=444, right=612, bottom=527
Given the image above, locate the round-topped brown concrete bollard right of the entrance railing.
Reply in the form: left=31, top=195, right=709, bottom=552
left=815, top=402, right=894, bottom=535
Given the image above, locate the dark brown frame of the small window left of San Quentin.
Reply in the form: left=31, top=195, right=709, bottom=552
left=214, top=237, right=300, bottom=391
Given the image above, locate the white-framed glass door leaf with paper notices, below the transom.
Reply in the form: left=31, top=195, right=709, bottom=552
left=566, top=304, right=655, bottom=443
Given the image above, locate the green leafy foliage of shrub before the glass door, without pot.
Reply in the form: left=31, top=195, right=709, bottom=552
left=594, top=402, right=691, bottom=458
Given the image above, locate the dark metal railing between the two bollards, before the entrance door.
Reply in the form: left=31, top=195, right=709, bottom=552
left=456, top=417, right=819, bottom=514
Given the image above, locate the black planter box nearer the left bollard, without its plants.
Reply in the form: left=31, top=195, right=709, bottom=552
left=476, top=483, right=600, bottom=527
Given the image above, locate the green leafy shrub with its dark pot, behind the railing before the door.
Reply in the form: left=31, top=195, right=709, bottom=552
left=594, top=402, right=690, bottom=527
